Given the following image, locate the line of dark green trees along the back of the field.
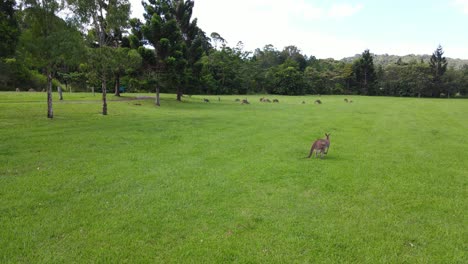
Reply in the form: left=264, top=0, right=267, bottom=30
left=0, top=0, right=468, bottom=106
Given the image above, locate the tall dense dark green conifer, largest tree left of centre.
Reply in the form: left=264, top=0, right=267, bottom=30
left=142, top=0, right=209, bottom=101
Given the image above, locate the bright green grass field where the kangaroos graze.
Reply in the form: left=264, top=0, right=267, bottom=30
left=0, top=92, right=468, bottom=263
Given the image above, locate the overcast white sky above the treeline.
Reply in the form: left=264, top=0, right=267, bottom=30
left=130, top=0, right=468, bottom=59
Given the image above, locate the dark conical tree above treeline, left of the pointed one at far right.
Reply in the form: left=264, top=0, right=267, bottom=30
left=353, top=50, right=376, bottom=95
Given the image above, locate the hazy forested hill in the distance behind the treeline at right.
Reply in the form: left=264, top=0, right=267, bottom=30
left=341, top=54, right=468, bottom=70
